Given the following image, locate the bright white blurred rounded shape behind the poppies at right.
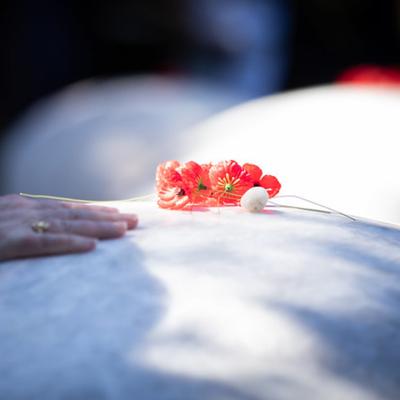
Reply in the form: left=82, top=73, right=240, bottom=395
left=186, top=86, right=400, bottom=224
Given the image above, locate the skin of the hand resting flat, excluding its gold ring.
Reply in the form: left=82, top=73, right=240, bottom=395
left=0, top=195, right=138, bottom=260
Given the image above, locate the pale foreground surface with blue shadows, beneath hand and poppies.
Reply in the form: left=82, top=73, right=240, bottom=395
left=0, top=202, right=400, bottom=400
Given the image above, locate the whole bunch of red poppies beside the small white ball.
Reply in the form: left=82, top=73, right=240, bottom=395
left=156, top=160, right=281, bottom=210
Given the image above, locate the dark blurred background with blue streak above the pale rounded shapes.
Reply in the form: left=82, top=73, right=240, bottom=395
left=0, top=0, right=400, bottom=136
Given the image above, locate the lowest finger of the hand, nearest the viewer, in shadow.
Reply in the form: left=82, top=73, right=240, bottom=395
left=3, top=232, right=96, bottom=259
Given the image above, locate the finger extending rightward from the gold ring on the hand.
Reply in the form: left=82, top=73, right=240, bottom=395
left=47, top=220, right=128, bottom=239
